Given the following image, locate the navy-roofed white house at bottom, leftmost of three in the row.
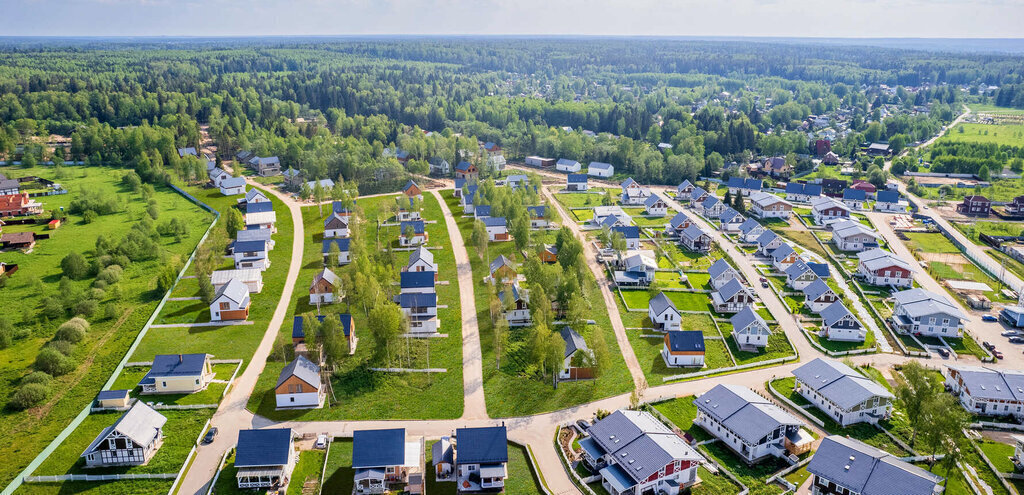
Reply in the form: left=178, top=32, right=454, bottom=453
left=234, top=428, right=294, bottom=491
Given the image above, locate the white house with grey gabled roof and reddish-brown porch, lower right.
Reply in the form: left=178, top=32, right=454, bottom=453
left=693, top=384, right=813, bottom=464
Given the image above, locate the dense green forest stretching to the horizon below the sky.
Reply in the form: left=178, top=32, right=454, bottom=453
left=0, top=38, right=1011, bottom=189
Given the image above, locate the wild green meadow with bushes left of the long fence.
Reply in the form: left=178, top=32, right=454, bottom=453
left=0, top=166, right=213, bottom=490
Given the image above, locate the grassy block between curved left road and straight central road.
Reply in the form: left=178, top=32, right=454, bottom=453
left=249, top=192, right=463, bottom=421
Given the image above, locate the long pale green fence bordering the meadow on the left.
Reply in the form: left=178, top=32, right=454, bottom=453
left=0, top=184, right=220, bottom=495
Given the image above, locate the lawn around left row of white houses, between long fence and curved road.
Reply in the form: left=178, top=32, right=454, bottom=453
left=131, top=188, right=294, bottom=373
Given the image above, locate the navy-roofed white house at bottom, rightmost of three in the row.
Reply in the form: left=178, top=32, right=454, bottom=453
left=455, top=425, right=509, bottom=493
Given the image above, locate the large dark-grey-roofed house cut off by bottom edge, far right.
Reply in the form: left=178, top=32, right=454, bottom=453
left=807, top=435, right=945, bottom=495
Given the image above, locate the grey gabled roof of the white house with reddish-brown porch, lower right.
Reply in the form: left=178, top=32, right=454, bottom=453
left=693, top=384, right=804, bottom=445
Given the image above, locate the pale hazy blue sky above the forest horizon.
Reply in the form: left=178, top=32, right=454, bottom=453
left=6, top=0, right=1024, bottom=38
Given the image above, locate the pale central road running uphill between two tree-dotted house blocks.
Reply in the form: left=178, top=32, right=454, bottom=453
left=430, top=191, right=487, bottom=419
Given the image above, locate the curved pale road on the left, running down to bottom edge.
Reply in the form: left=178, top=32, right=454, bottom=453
left=178, top=182, right=306, bottom=494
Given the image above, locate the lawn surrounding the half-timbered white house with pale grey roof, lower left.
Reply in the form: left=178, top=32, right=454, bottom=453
left=33, top=409, right=212, bottom=476
